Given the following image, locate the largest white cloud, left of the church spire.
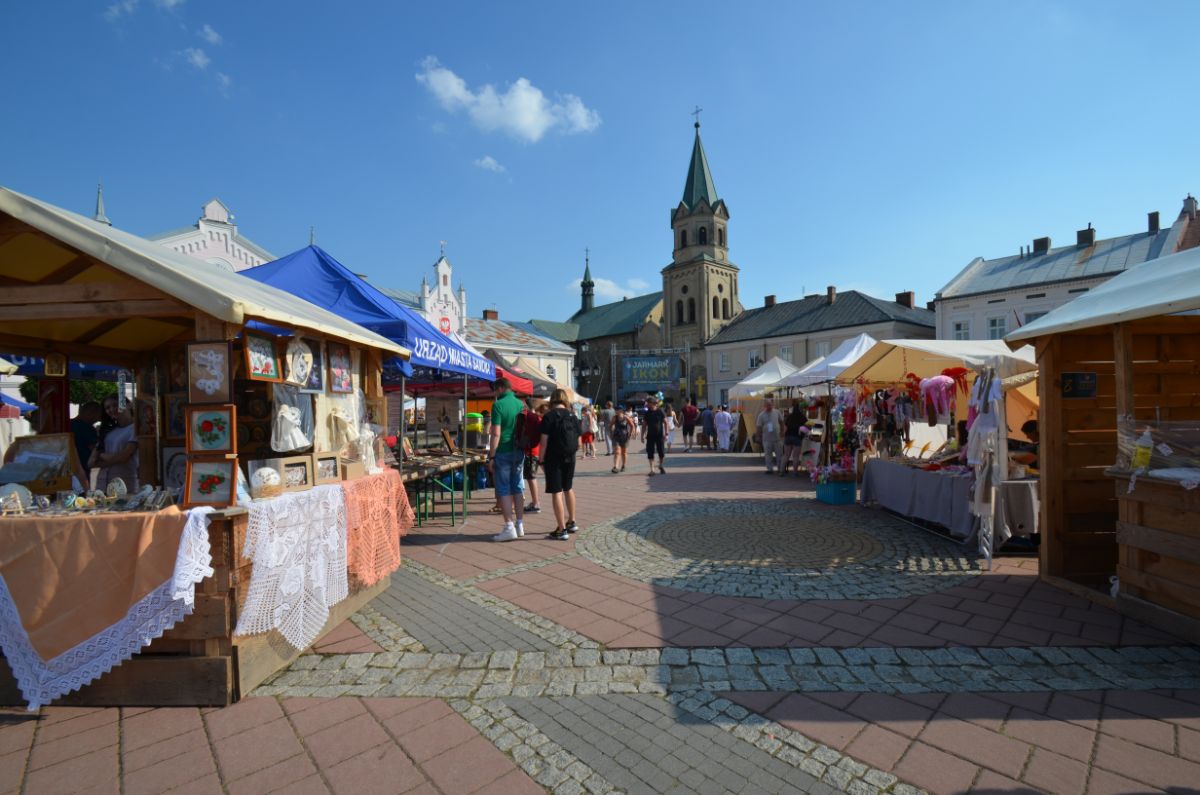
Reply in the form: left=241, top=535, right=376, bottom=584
left=416, top=55, right=600, bottom=143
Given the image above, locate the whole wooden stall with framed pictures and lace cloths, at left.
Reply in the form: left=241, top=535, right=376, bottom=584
left=0, top=189, right=412, bottom=709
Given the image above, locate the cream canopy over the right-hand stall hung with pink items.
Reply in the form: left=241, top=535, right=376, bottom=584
left=838, top=340, right=1038, bottom=383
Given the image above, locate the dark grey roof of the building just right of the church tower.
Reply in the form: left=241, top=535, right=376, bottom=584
left=708, top=289, right=935, bottom=345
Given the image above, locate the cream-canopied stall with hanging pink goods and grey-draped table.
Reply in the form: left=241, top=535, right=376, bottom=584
left=838, top=340, right=1037, bottom=556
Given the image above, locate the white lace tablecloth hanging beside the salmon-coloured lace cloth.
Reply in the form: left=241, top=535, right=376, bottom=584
left=235, top=485, right=349, bottom=650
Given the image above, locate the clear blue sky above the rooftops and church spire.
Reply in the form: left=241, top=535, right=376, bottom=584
left=0, top=0, right=1200, bottom=319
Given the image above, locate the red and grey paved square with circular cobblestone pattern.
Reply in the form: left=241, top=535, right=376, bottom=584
left=0, top=454, right=1200, bottom=795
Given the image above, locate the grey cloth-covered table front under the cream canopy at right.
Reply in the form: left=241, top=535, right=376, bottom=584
left=860, top=459, right=977, bottom=539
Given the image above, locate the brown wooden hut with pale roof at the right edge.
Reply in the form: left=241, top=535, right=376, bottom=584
left=1006, top=241, right=1200, bottom=641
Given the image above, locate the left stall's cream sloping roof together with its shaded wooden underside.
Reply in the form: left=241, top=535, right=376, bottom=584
left=0, top=187, right=409, bottom=358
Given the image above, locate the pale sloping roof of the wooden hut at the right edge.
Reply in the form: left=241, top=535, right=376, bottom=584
left=1004, top=242, right=1200, bottom=342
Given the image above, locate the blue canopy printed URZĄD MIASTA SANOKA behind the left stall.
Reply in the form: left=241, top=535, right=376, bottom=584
left=240, top=246, right=496, bottom=381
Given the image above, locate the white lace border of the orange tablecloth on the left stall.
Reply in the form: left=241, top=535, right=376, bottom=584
left=0, top=508, right=212, bottom=711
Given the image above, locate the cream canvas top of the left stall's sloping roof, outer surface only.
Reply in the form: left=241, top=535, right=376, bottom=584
left=0, top=187, right=409, bottom=358
